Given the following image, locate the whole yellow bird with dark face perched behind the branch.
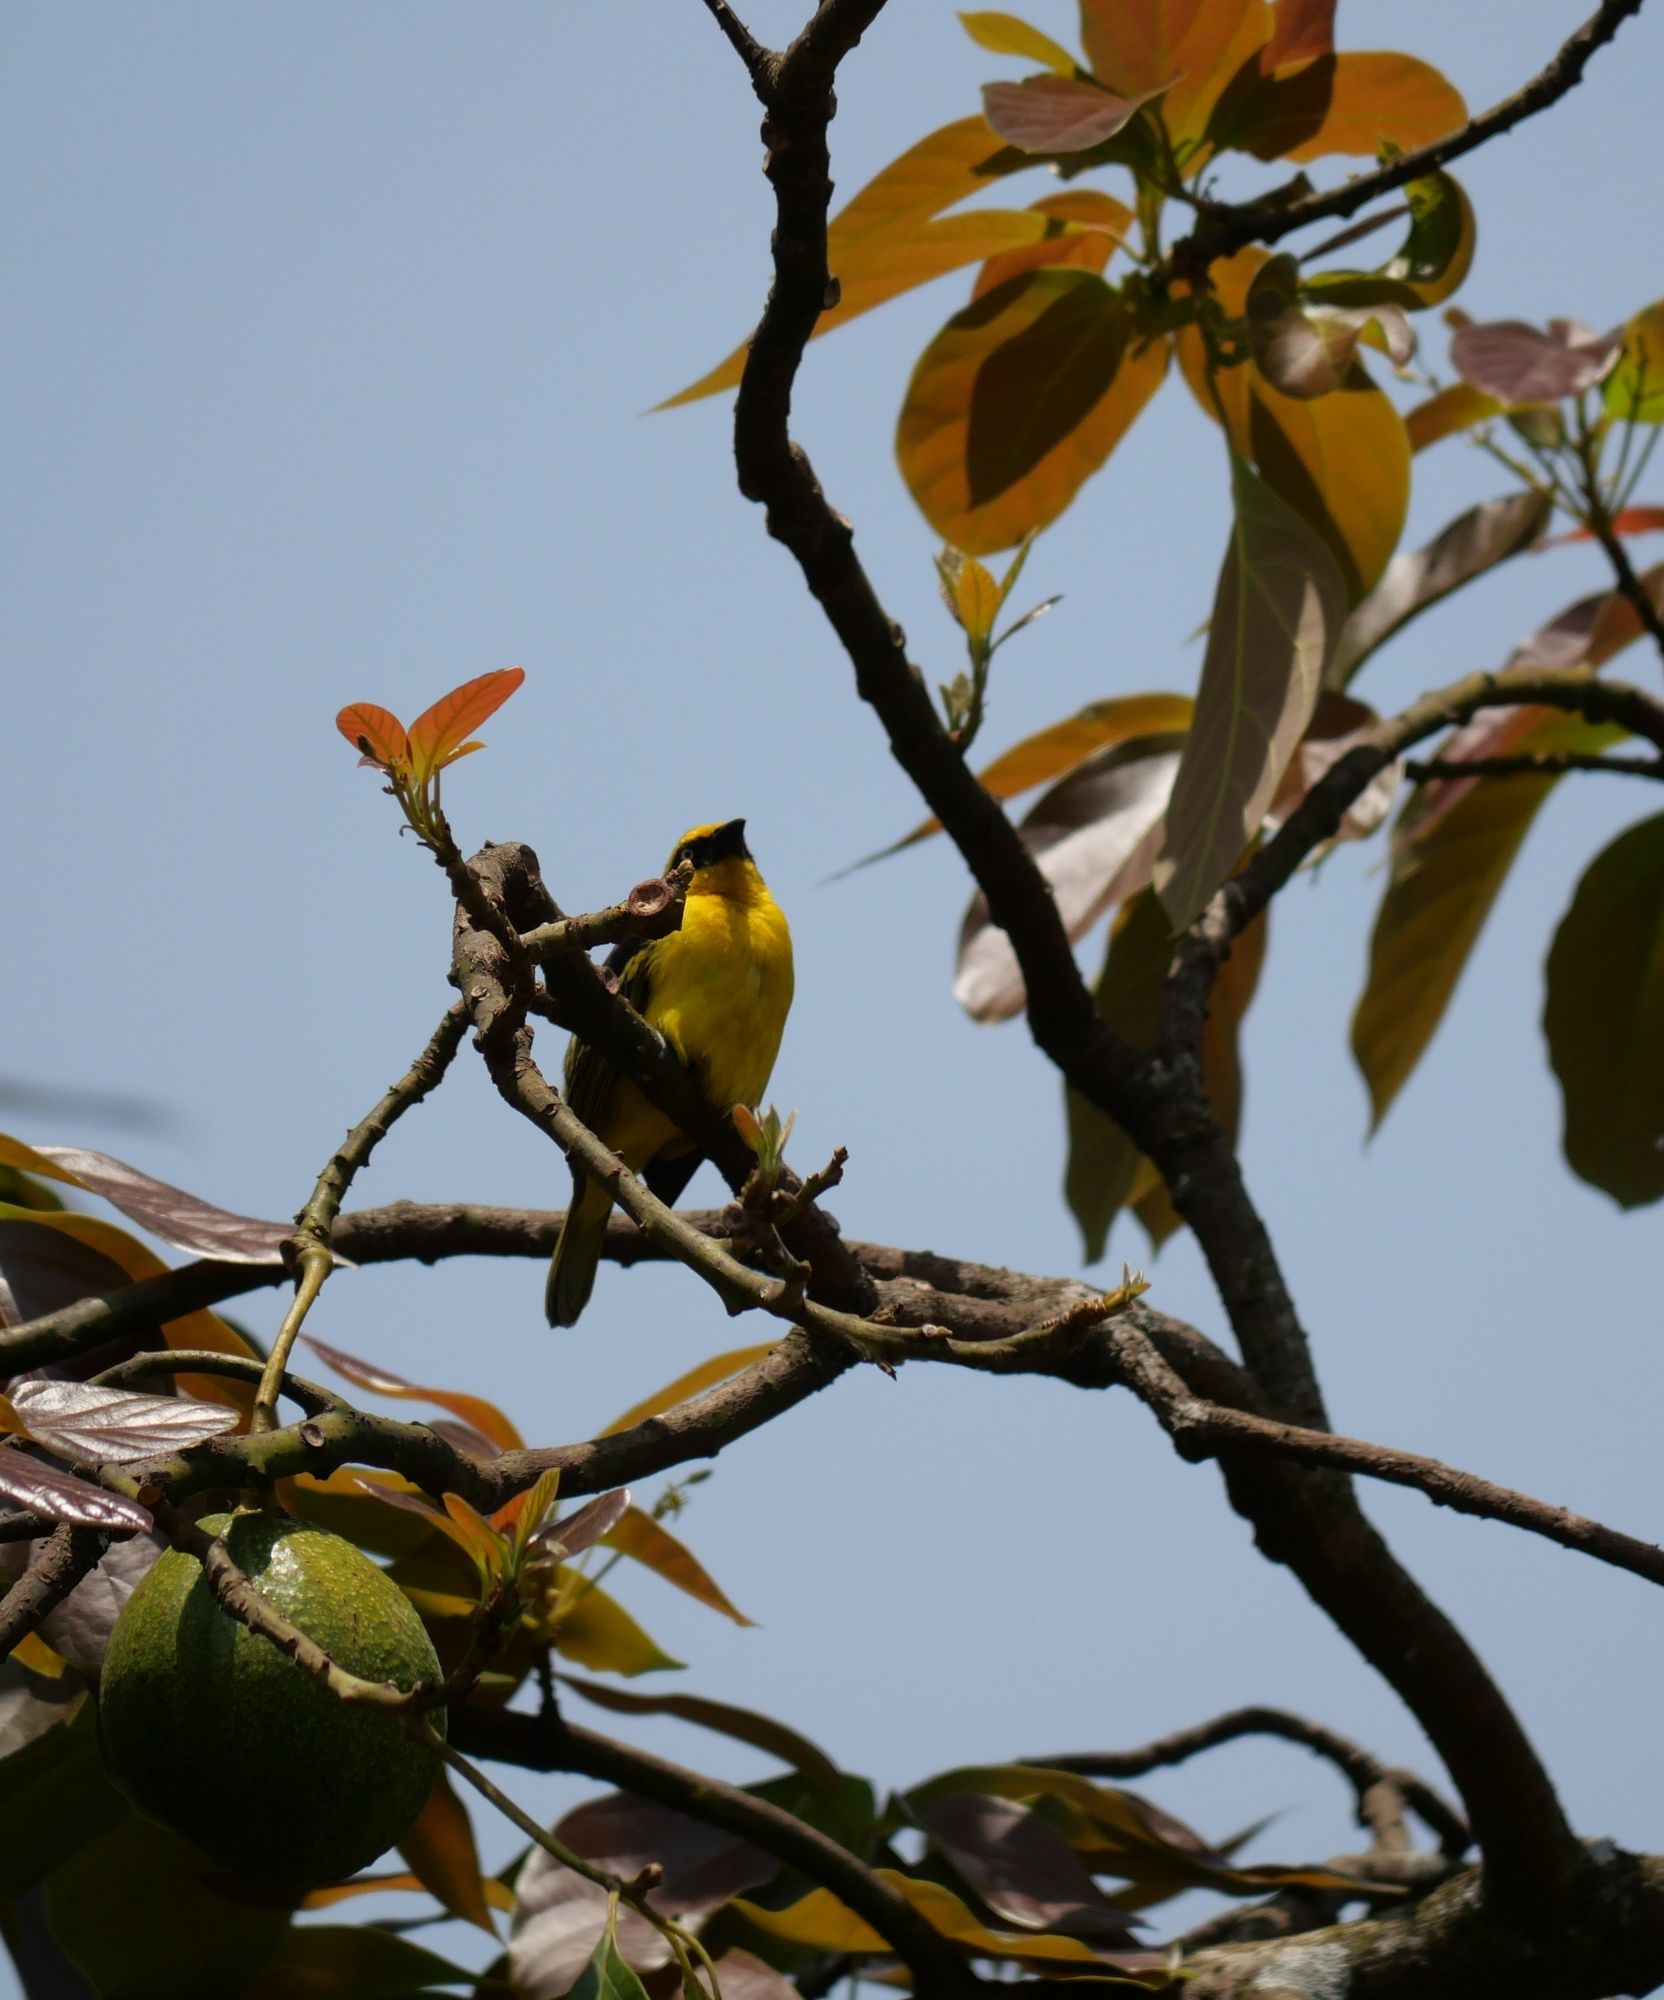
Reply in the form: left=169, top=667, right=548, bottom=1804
left=544, top=820, right=792, bottom=1326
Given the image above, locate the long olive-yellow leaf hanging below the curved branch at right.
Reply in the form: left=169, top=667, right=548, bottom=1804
left=1352, top=710, right=1622, bottom=1132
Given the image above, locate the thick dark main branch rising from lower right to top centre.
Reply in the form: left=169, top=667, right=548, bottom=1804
left=696, top=0, right=1582, bottom=1920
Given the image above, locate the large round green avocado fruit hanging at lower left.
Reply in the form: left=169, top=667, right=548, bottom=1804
left=98, top=1514, right=444, bottom=1890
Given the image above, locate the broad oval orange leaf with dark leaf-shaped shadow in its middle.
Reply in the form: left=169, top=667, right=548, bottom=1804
left=896, top=270, right=1168, bottom=554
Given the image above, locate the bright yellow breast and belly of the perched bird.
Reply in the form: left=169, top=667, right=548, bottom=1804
left=646, top=860, right=792, bottom=1108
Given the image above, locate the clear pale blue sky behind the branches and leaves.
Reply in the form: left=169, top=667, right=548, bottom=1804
left=0, top=0, right=1664, bottom=1986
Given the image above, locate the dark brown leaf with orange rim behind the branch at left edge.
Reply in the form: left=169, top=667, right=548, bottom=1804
left=0, top=1202, right=254, bottom=1416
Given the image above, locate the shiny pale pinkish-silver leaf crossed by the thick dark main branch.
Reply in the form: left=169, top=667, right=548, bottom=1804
left=954, top=734, right=1184, bottom=1022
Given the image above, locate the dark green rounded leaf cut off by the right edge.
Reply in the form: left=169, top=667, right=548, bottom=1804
left=1542, top=814, right=1664, bottom=1208
